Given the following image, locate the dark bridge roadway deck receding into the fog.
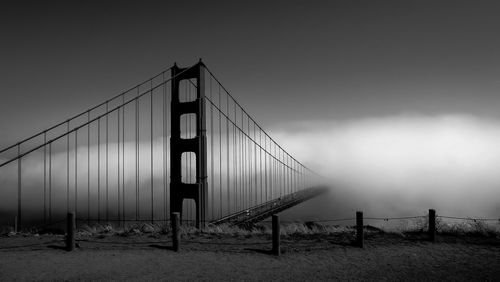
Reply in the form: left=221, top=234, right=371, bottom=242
left=210, top=187, right=327, bottom=226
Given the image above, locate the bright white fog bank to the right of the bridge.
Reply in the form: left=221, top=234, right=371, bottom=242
left=273, top=115, right=500, bottom=218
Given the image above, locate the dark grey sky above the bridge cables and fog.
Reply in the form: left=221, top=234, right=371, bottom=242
left=0, top=1, right=500, bottom=145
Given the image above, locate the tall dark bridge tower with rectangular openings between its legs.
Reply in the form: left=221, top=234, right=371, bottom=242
left=170, top=60, right=208, bottom=228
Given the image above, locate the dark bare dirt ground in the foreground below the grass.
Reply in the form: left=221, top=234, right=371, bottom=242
left=0, top=231, right=500, bottom=281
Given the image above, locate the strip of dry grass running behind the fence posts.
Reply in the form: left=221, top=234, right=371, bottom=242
left=0, top=216, right=500, bottom=237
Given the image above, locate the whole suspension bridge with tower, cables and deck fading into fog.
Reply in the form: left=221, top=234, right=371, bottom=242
left=0, top=60, right=324, bottom=227
